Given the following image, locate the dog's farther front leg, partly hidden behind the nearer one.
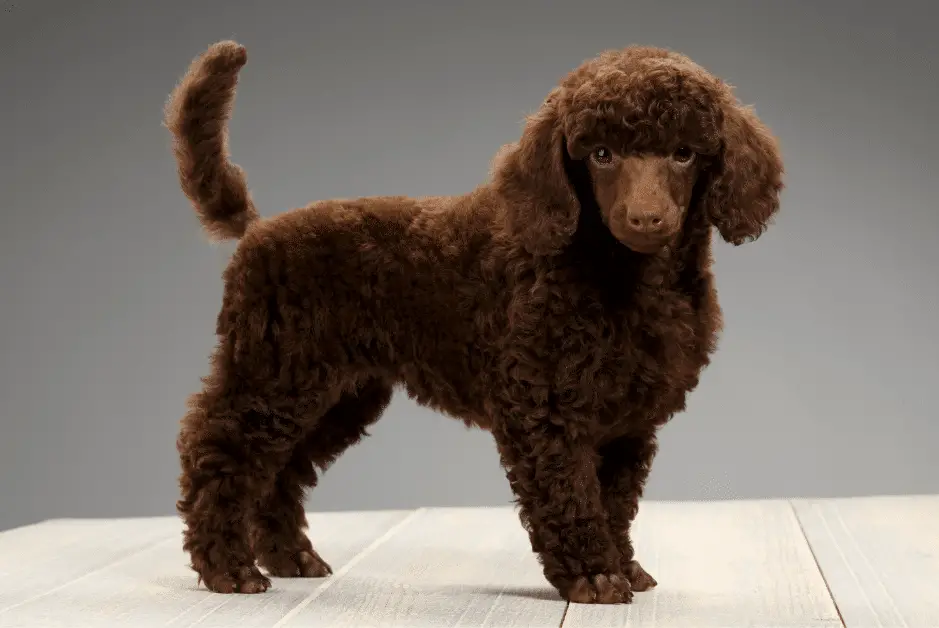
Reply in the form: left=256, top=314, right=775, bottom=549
left=599, top=432, right=658, bottom=591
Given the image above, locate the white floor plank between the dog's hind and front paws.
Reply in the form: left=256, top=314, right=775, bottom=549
left=272, top=508, right=567, bottom=628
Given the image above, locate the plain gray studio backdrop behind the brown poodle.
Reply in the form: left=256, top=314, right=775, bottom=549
left=0, top=0, right=939, bottom=528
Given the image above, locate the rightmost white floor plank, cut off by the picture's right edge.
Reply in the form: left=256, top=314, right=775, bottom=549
left=793, top=496, right=939, bottom=628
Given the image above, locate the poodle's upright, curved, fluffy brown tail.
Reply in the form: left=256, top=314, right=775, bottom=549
left=164, top=41, right=259, bottom=240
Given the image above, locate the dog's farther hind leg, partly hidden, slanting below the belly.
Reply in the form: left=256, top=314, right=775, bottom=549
left=251, top=378, right=392, bottom=578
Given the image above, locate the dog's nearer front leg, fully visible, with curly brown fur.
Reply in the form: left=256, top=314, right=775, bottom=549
left=493, top=417, right=632, bottom=604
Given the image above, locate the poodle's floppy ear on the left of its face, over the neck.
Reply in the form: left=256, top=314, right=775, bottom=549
left=493, top=92, right=580, bottom=255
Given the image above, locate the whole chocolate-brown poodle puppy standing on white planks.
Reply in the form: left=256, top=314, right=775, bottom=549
left=167, top=42, right=783, bottom=603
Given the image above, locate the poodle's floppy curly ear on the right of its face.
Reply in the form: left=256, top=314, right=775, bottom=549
left=702, top=105, right=783, bottom=245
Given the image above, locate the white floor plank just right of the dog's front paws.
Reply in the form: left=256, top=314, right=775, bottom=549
left=564, top=500, right=841, bottom=628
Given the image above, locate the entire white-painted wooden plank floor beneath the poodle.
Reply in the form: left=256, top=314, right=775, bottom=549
left=0, top=496, right=939, bottom=628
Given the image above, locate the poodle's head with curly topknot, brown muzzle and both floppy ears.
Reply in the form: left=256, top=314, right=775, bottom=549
left=493, top=47, right=783, bottom=255
